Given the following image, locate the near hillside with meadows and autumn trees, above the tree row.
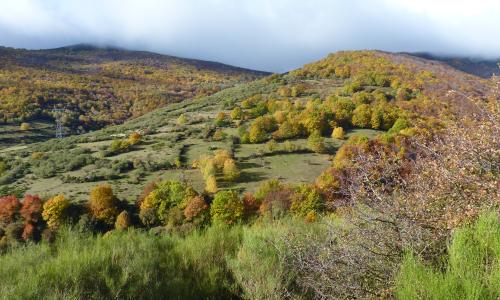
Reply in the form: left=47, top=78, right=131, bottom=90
left=0, top=51, right=495, bottom=201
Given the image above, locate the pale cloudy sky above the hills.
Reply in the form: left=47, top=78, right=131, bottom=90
left=0, top=0, right=500, bottom=72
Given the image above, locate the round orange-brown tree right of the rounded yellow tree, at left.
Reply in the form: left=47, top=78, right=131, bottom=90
left=88, top=184, right=119, bottom=225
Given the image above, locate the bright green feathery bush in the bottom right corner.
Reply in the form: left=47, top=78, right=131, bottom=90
left=396, top=213, right=500, bottom=300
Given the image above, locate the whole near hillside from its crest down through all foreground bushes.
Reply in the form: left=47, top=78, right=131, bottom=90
left=0, top=51, right=500, bottom=300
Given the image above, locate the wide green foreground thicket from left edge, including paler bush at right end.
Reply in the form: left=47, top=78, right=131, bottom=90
left=0, top=220, right=308, bottom=299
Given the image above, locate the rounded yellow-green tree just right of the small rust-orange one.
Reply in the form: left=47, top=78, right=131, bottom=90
left=210, top=190, right=245, bottom=224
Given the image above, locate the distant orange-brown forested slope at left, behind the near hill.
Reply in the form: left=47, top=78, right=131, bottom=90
left=0, top=44, right=267, bottom=130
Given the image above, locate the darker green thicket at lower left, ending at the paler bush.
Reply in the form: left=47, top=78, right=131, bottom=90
left=0, top=227, right=241, bottom=299
